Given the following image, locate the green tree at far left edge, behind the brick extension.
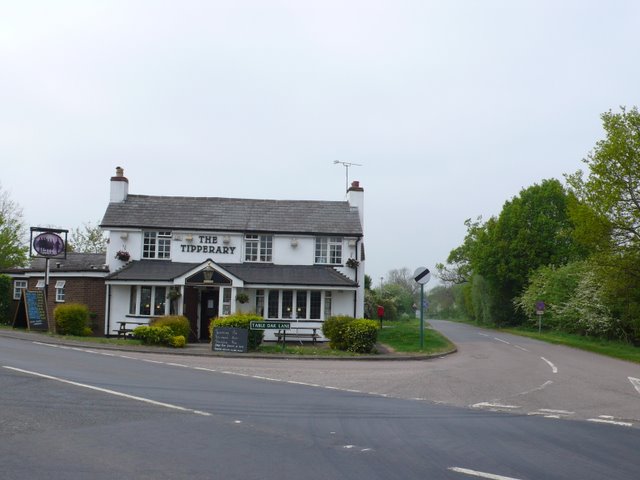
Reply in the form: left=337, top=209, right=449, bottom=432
left=0, top=186, right=28, bottom=268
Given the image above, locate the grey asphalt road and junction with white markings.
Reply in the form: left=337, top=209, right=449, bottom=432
left=0, top=322, right=640, bottom=480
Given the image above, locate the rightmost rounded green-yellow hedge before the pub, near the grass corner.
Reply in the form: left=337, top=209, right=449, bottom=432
left=322, top=316, right=378, bottom=353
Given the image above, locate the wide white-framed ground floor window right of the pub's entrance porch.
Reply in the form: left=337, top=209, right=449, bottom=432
left=256, top=290, right=331, bottom=320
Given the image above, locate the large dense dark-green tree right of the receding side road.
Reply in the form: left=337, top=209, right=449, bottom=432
left=440, top=179, right=585, bottom=325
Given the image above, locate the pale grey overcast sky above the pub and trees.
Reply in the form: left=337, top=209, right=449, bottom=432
left=0, top=0, right=640, bottom=286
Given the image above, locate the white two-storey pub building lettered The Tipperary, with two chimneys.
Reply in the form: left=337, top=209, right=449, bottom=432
left=101, top=167, right=365, bottom=341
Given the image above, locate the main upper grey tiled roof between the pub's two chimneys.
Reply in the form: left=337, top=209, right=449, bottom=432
left=101, top=195, right=362, bottom=236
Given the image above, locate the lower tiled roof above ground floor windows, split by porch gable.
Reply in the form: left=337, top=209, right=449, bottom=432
left=107, top=260, right=357, bottom=288
